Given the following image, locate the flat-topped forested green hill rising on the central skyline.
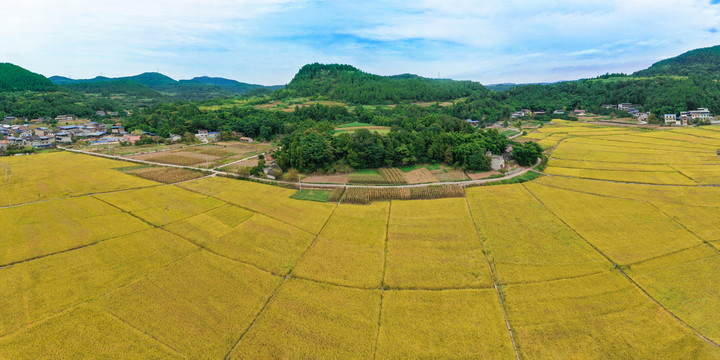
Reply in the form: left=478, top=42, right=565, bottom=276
left=287, top=63, right=487, bottom=104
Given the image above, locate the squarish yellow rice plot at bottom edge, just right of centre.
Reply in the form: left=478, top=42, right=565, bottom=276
left=376, top=289, right=515, bottom=359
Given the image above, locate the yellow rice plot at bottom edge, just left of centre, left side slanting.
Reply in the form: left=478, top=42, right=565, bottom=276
left=230, top=279, right=380, bottom=359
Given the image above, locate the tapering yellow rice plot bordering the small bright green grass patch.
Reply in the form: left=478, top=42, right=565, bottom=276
left=180, top=177, right=335, bottom=234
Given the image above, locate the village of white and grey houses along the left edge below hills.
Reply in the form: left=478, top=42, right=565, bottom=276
left=0, top=112, right=253, bottom=151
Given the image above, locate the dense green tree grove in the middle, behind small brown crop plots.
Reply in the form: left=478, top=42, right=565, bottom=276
left=275, top=115, right=508, bottom=172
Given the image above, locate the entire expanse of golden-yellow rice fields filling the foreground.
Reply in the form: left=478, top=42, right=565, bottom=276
left=0, top=121, right=720, bottom=359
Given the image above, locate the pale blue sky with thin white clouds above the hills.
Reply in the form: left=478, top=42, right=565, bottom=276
left=0, top=0, right=720, bottom=85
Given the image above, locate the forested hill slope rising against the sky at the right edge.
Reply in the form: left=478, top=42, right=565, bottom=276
left=633, top=45, right=720, bottom=79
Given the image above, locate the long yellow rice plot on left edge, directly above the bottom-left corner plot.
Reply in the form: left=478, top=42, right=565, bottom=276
left=0, top=229, right=196, bottom=335
